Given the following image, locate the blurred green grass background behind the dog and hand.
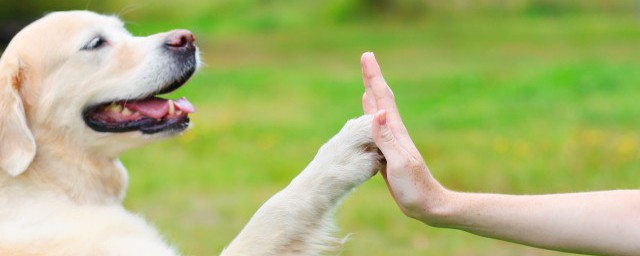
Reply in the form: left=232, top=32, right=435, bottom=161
left=0, top=0, right=640, bottom=255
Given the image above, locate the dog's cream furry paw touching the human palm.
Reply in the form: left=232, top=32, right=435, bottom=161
left=316, top=115, right=384, bottom=188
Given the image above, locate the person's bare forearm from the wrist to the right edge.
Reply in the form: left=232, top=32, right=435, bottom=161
left=422, top=190, right=640, bottom=255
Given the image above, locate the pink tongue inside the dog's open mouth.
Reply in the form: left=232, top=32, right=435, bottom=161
left=124, top=97, right=196, bottom=119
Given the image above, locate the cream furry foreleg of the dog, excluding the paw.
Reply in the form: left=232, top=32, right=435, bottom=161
left=222, top=163, right=344, bottom=255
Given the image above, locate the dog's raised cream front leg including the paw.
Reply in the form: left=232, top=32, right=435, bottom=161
left=222, top=115, right=382, bottom=256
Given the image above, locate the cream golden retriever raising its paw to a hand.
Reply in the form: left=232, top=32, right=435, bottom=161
left=0, top=11, right=383, bottom=256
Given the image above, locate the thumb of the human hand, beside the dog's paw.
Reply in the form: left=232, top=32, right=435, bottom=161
left=371, top=109, right=401, bottom=161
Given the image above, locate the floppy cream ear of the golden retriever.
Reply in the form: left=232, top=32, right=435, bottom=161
left=0, top=56, right=36, bottom=177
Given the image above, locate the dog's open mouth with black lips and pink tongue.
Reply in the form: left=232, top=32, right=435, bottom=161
left=83, top=72, right=195, bottom=134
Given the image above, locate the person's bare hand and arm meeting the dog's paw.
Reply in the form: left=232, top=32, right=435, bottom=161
left=362, top=53, right=640, bottom=255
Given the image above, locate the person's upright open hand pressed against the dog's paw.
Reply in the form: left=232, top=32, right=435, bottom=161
left=361, top=52, right=447, bottom=224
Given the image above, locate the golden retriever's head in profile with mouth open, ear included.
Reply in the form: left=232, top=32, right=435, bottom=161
left=0, top=11, right=198, bottom=176
